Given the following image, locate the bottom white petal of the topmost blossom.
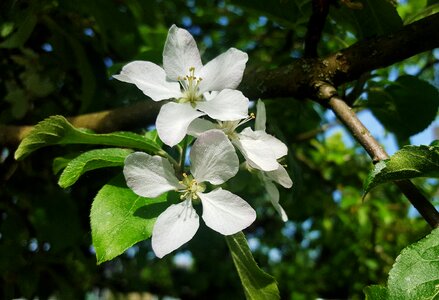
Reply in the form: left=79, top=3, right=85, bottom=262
left=156, top=102, right=204, bottom=147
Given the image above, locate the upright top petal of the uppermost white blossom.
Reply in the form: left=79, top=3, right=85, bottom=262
left=163, top=25, right=203, bottom=80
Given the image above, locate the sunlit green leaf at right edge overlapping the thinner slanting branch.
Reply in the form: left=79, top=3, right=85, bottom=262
left=364, top=145, right=439, bottom=194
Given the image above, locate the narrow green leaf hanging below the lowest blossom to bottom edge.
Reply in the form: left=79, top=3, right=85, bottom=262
left=226, top=232, right=280, bottom=300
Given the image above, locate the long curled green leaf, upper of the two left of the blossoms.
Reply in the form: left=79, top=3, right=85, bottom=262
left=15, top=116, right=161, bottom=160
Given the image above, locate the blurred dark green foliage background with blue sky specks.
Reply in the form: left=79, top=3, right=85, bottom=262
left=0, top=0, right=439, bottom=299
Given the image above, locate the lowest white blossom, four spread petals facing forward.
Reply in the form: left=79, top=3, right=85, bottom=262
left=124, top=130, right=256, bottom=258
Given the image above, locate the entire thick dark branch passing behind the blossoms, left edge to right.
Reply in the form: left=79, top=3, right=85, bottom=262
left=0, top=13, right=439, bottom=146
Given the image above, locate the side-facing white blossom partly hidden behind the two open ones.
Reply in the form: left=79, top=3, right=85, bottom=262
left=188, top=101, right=293, bottom=222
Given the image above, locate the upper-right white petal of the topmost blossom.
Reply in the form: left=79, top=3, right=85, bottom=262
left=198, top=48, right=248, bottom=92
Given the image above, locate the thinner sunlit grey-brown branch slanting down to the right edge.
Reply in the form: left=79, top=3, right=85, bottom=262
left=319, top=84, right=439, bottom=228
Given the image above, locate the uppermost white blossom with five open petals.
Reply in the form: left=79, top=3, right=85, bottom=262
left=113, top=25, right=248, bottom=146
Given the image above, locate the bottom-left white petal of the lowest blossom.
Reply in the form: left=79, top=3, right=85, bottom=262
left=151, top=200, right=200, bottom=258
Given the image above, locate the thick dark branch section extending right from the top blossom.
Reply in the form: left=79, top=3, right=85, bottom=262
left=240, top=13, right=439, bottom=99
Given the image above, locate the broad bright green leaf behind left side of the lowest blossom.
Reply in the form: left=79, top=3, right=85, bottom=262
left=90, top=175, right=167, bottom=264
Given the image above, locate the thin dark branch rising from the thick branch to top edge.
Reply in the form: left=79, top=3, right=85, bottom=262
left=304, top=0, right=332, bottom=58
